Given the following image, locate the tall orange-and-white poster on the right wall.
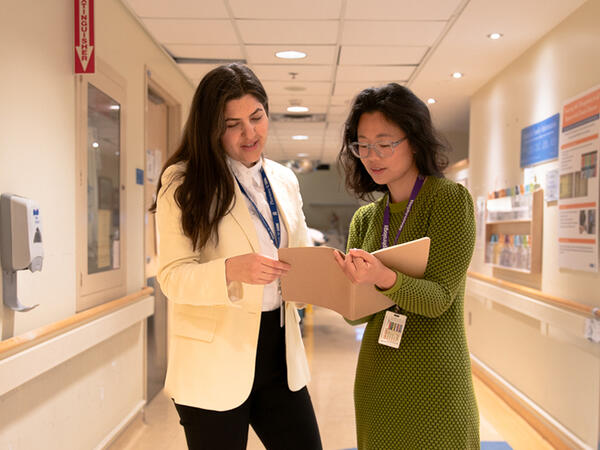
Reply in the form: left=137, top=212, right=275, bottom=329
left=558, top=85, right=600, bottom=272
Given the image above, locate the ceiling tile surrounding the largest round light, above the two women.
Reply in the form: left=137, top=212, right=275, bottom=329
left=246, top=44, right=336, bottom=65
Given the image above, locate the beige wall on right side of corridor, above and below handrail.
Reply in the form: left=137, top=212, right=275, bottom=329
left=466, top=0, right=600, bottom=448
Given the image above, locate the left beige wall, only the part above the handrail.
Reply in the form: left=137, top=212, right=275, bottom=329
left=0, top=0, right=193, bottom=334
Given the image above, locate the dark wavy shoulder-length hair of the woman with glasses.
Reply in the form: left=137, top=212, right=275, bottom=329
left=338, top=83, right=449, bottom=200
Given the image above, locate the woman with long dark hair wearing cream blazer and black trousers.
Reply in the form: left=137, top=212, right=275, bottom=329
left=153, top=64, right=321, bottom=450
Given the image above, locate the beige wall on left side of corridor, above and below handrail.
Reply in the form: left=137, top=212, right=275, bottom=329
left=0, top=0, right=193, bottom=449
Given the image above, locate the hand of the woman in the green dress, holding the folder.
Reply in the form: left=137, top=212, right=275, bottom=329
left=334, top=248, right=397, bottom=290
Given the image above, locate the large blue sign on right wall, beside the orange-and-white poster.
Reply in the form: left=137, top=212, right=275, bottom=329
left=521, top=114, right=560, bottom=167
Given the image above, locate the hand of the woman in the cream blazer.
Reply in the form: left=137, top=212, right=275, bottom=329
left=225, top=253, right=291, bottom=284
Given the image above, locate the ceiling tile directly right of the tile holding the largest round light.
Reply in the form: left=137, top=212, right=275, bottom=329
left=340, top=45, right=429, bottom=65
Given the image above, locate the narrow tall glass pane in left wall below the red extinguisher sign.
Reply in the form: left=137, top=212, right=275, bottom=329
left=87, top=84, right=121, bottom=274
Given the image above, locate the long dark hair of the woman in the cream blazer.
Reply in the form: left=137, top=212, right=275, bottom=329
left=150, top=63, right=269, bottom=250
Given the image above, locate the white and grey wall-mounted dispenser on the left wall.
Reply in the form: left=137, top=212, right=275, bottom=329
left=0, top=194, right=44, bottom=312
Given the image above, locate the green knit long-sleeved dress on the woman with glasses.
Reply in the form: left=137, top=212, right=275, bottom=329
left=348, top=177, right=480, bottom=450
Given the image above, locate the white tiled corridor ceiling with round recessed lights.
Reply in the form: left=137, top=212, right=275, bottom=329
left=123, top=0, right=584, bottom=163
